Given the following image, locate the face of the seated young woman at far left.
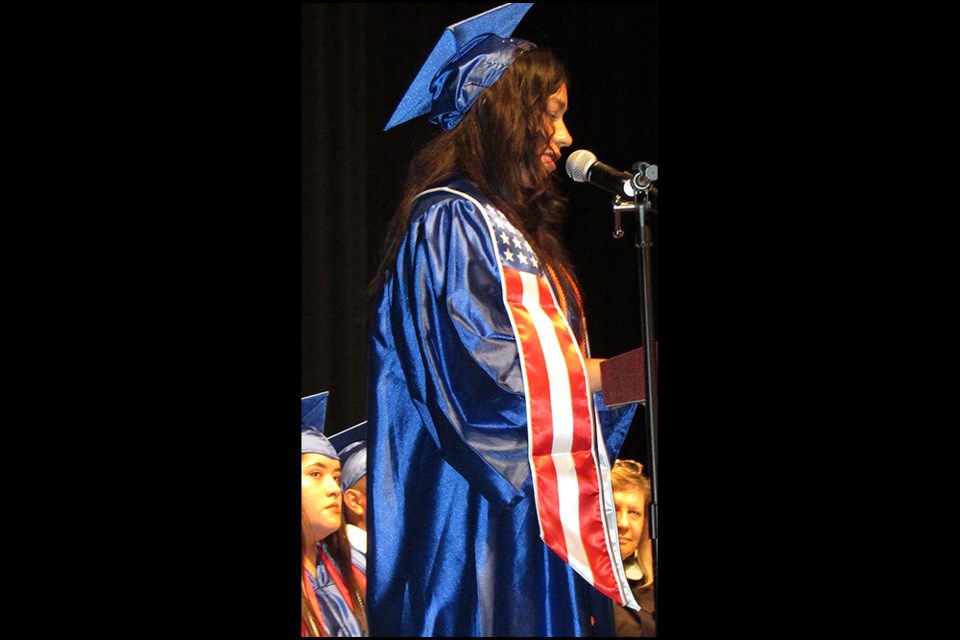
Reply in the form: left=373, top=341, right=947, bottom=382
left=300, top=453, right=341, bottom=544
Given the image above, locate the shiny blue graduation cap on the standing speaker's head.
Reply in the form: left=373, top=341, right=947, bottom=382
left=383, top=2, right=533, bottom=131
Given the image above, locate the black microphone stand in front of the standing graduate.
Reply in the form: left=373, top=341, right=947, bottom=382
left=613, top=162, right=660, bottom=620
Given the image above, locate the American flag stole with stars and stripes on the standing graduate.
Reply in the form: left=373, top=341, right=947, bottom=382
left=420, top=188, right=639, bottom=609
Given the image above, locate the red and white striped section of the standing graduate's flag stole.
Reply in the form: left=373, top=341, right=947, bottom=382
left=503, top=268, right=632, bottom=605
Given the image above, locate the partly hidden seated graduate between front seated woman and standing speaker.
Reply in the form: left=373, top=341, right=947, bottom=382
left=330, top=422, right=367, bottom=574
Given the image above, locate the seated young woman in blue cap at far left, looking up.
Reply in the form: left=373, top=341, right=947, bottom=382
left=300, top=392, right=367, bottom=637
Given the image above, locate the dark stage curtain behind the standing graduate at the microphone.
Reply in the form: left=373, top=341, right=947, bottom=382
left=301, top=3, right=669, bottom=468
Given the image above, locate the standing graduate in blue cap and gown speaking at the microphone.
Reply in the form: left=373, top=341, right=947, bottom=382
left=367, top=4, right=638, bottom=637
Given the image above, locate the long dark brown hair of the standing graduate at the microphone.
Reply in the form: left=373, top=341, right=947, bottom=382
left=371, top=48, right=572, bottom=295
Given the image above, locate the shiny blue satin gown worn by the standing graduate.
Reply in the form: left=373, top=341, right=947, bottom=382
left=367, top=180, right=636, bottom=636
